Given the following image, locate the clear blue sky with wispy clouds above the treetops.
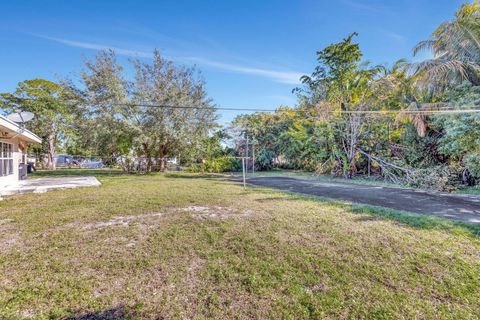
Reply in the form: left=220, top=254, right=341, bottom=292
left=0, top=0, right=464, bottom=122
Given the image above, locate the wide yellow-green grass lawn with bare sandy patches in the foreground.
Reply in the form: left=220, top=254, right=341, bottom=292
left=0, top=170, right=480, bottom=319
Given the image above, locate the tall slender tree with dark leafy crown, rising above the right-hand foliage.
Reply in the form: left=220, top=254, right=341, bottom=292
left=301, top=33, right=383, bottom=176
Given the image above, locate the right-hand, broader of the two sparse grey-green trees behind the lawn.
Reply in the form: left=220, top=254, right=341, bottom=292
left=128, top=51, right=217, bottom=171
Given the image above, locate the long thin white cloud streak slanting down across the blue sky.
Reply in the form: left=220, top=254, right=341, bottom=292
left=39, top=36, right=303, bottom=84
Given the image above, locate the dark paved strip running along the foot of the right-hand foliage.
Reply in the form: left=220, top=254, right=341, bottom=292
left=235, top=177, right=480, bottom=223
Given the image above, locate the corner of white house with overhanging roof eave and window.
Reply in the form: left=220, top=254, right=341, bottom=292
left=0, top=115, right=42, bottom=188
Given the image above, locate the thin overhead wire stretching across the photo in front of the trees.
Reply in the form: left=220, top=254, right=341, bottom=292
left=2, top=98, right=480, bottom=115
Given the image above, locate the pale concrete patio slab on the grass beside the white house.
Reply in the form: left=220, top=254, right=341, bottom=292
left=0, top=177, right=101, bottom=196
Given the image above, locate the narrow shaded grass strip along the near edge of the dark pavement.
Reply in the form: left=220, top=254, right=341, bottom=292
left=250, top=186, right=480, bottom=238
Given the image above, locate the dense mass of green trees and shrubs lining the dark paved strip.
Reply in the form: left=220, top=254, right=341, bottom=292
left=234, top=1, right=480, bottom=191
